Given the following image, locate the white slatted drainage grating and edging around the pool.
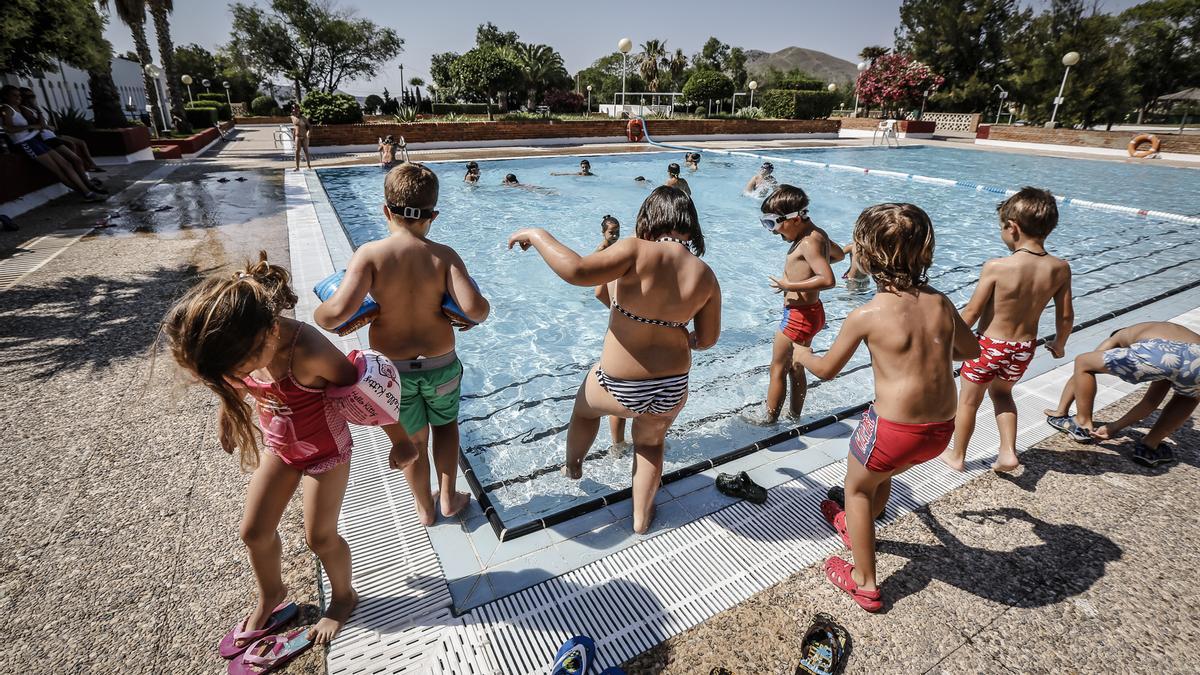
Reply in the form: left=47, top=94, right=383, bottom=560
left=284, top=154, right=1200, bottom=674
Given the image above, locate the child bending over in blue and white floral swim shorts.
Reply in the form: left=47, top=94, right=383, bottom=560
left=1045, top=321, right=1200, bottom=466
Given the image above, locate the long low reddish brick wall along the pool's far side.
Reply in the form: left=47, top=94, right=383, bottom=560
left=304, top=119, right=839, bottom=145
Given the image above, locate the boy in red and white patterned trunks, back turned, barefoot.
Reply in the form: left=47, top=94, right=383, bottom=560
left=942, top=187, right=1075, bottom=471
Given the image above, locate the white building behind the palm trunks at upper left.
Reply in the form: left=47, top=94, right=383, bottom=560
left=0, top=56, right=167, bottom=119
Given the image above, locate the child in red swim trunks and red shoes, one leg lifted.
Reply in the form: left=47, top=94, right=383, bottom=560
left=796, top=204, right=979, bottom=611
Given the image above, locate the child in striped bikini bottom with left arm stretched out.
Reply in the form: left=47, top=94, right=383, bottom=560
left=509, top=186, right=721, bottom=533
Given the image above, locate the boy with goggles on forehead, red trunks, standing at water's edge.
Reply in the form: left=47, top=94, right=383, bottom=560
left=746, top=185, right=844, bottom=425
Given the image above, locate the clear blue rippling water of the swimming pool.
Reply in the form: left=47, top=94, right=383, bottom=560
left=319, top=148, right=1200, bottom=525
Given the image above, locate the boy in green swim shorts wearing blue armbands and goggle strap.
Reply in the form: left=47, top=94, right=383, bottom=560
left=313, top=162, right=491, bottom=526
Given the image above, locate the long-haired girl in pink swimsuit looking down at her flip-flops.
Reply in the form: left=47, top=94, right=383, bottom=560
left=162, top=252, right=358, bottom=658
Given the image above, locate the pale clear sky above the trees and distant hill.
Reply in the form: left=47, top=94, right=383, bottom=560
left=106, top=0, right=1138, bottom=95
